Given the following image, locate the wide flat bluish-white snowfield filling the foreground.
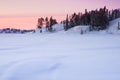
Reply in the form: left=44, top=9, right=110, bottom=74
left=0, top=18, right=120, bottom=80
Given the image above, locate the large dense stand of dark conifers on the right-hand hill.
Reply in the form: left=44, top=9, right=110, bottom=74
left=62, top=6, right=120, bottom=31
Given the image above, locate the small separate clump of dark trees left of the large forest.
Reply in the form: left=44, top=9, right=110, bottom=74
left=37, top=16, right=57, bottom=33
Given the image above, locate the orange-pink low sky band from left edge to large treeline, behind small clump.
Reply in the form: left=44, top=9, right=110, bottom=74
left=0, top=16, right=65, bottom=29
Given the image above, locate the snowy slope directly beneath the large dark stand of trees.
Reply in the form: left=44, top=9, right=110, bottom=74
left=66, top=18, right=120, bottom=34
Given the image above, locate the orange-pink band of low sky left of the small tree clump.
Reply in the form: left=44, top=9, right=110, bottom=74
left=0, top=17, right=37, bottom=29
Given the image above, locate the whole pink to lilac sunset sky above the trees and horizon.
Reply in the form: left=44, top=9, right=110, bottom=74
left=0, top=0, right=120, bottom=28
